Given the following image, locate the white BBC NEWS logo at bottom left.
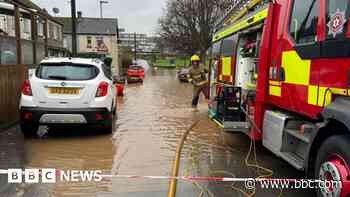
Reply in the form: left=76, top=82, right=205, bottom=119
left=7, top=169, right=103, bottom=183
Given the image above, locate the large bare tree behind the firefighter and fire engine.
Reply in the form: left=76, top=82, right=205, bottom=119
left=159, top=0, right=227, bottom=57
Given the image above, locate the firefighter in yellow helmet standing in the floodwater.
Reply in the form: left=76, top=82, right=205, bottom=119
left=188, top=55, right=208, bottom=111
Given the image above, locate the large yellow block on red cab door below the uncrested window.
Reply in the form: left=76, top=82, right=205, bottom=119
left=282, top=51, right=311, bottom=86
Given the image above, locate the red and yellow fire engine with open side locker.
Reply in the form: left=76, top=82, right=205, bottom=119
left=209, top=0, right=350, bottom=197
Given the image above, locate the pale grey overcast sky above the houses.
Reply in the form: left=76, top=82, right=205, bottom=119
left=32, top=0, right=166, bottom=34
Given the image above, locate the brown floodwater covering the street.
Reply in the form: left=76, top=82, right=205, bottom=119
left=0, top=70, right=314, bottom=197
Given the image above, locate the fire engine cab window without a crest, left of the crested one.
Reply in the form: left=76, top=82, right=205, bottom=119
left=289, top=0, right=320, bottom=44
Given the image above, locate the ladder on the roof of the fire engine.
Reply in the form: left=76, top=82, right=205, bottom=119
left=226, top=0, right=268, bottom=23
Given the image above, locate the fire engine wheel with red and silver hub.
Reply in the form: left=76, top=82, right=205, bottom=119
left=315, top=135, right=350, bottom=197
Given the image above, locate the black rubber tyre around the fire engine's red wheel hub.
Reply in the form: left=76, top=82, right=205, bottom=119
left=314, top=135, right=350, bottom=197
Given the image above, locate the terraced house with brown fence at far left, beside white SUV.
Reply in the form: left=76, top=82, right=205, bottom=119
left=0, top=0, right=66, bottom=127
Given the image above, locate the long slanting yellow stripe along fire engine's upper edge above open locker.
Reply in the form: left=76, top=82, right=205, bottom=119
left=213, top=8, right=268, bottom=42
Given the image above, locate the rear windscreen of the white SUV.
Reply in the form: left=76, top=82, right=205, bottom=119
left=37, top=64, right=99, bottom=81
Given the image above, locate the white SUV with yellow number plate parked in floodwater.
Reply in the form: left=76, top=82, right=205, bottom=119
left=20, top=58, right=117, bottom=136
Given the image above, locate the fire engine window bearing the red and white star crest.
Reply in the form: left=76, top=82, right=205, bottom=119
left=326, top=0, right=350, bottom=39
